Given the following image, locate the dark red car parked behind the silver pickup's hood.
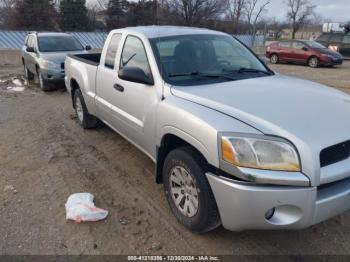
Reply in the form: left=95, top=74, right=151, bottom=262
left=266, top=40, right=343, bottom=68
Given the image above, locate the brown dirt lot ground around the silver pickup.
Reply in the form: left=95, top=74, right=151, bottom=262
left=0, top=62, right=350, bottom=255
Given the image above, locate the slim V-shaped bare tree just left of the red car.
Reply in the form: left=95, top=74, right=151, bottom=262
left=245, top=0, right=271, bottom=45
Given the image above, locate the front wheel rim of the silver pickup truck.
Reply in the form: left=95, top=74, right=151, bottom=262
left=169, top=166, right=199, bottom=217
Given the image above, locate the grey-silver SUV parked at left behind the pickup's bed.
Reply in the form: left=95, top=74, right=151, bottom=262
left=22, top=32, right=91, bottom=91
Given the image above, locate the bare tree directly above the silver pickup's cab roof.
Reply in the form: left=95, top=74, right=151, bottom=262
left=167, top=0, right=227, bottom=26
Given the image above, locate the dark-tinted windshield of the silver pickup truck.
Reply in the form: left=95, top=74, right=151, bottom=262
left=150, top=34, right=273, bottom=85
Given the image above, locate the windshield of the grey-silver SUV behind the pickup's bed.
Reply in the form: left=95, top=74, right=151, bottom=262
left=38, top=36, right=84, bottom=52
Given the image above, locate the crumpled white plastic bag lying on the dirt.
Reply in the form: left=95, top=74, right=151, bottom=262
left=65, top=193, right=108, bottom=223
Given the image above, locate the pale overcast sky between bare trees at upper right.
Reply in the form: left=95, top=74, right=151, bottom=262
left=260, top=0, right=350, bottom=22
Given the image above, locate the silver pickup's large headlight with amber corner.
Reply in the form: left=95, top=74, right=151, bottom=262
left=220, top=135, right=300, bottom=171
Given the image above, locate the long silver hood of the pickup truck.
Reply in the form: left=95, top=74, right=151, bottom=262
left=171, top=75, right=350, bottom=183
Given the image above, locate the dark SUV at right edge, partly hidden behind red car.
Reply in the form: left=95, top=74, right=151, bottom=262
left=316, top=33, right=350, bottom=58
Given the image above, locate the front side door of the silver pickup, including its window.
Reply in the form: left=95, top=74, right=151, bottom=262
left=105, top=35, right=158, bottom=152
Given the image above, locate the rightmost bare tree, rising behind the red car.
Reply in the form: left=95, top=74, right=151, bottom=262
left=286, top=0, right=315, bottom=39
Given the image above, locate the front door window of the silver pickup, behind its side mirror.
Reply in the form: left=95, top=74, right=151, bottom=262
left=120, top=36, right=151, bottom=76
